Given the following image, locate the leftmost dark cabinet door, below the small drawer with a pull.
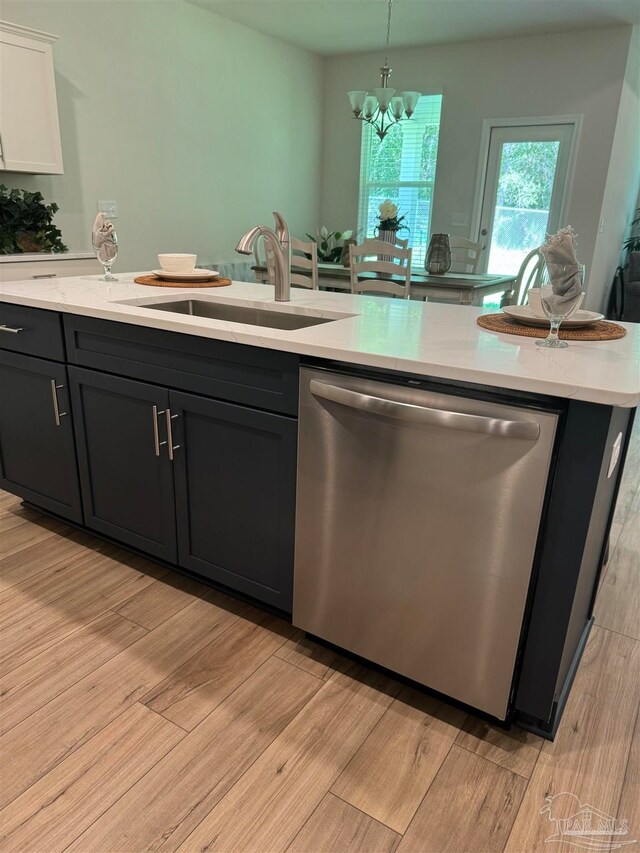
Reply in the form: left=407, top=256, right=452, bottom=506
left=0, top=350, right=82, bottom=522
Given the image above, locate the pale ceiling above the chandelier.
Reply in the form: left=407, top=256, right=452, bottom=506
left=190, top=0, right=640, bottom=55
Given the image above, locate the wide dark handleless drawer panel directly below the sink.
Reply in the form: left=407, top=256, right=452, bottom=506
left=64, top=314, right=299, bottom=415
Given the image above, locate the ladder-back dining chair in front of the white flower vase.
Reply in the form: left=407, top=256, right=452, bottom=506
left=349, top=240, right=411, bottom=299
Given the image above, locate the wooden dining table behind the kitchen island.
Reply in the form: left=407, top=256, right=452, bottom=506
left=252, top=263, right=516, bottom=306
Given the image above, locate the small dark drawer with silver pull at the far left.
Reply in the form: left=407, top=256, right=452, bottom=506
left=0, top=302, right=64, bottom=361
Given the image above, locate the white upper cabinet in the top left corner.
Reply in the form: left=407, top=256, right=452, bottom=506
left=0, top=21, right=64, bottom=175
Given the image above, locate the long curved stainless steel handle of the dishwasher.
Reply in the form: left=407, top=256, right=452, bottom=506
left=309, top=379, right=540, bottom=441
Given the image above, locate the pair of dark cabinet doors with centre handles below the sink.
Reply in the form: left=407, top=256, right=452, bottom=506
left=69, top=366, right=297, bottom=611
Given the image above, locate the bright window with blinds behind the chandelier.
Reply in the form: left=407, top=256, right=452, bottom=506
left=358, top=95, right=442, bottom=267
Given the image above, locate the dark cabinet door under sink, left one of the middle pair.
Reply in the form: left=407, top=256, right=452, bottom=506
left=69, top=367, right=176, bottom=562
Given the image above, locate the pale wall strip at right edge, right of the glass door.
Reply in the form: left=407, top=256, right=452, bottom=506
left=589, top=27, right=640, bottom=312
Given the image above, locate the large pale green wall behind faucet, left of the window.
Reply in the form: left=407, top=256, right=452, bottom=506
left=0, top=0, right=322, bottom=272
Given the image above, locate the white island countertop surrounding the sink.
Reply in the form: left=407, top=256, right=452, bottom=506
left=0, top=273, right=640, bottom=407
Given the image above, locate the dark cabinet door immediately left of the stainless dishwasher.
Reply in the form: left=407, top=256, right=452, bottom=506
left=170, top=391, right=297, bottom=612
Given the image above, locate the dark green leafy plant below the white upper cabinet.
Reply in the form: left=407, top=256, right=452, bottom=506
left=0, top=184, right=68, bottom=255
